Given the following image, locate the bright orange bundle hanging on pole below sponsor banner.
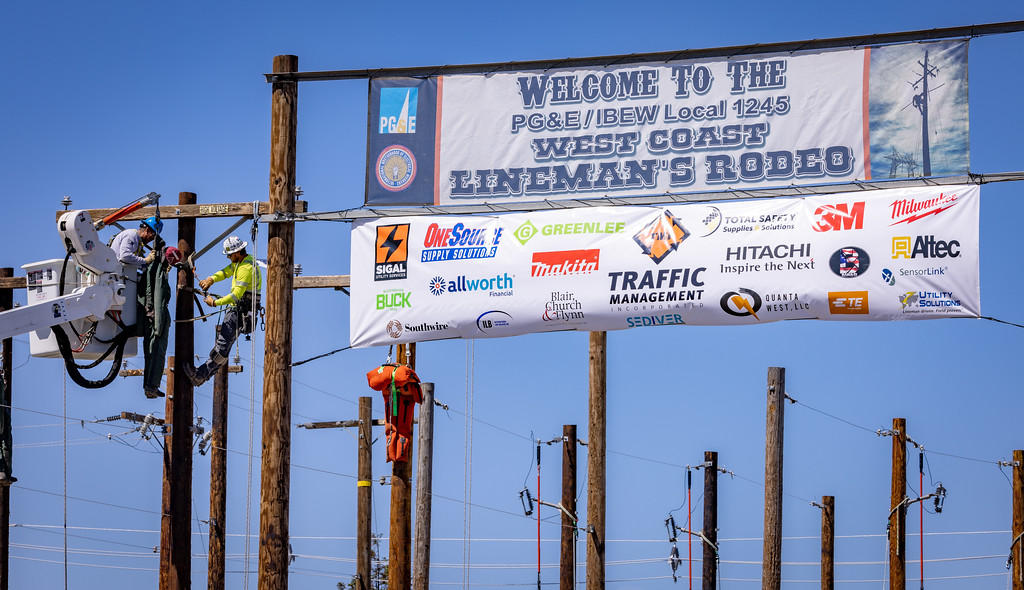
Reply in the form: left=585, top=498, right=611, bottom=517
left=367, top=365, right=423, bottom=461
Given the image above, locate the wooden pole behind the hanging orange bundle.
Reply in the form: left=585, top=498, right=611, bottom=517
left=387, top=343, right=416, bottom=590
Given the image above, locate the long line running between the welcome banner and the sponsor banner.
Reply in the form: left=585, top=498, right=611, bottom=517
left=261, top=171, right=1024, bottom=223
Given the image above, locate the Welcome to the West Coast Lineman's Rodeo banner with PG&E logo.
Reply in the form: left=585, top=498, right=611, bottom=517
left=366, top=41, right=969, bottom=205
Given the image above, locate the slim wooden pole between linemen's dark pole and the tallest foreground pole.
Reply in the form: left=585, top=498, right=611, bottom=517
left=207, top=326, right=227, bottom=590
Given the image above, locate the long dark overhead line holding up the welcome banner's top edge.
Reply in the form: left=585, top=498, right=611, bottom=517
left=263, top=20, right=1024, bottom=84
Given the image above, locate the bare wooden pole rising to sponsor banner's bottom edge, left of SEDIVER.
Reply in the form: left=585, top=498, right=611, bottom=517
left=587, top=332, right=608, bottom=590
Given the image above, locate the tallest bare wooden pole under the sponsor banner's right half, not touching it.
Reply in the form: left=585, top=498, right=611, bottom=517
left=761, top=367, right=785, bottom=590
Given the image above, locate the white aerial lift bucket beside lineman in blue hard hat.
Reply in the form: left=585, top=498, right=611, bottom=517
left=12, top=211, right=138, bottom=361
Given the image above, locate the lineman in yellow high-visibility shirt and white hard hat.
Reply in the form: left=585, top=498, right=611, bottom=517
left=182, top=236, right=262, bottom=386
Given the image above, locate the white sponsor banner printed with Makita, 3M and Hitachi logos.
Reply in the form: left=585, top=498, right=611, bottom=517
left=350, top=185, right=981, bottom=346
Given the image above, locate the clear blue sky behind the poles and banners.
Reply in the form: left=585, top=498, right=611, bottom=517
left=0, top=0, right=1024, bottom=589
